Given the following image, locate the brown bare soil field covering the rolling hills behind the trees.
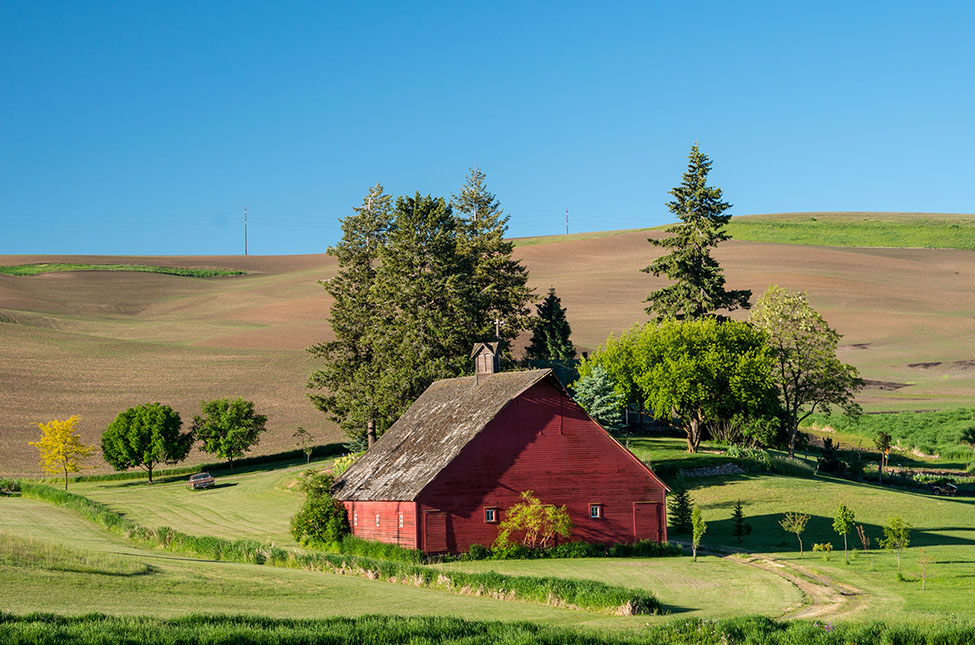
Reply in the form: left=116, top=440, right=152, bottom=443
left=0, top=231, right=975, bottom=474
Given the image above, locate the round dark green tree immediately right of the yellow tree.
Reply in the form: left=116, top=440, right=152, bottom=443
left=102, top=403, right=194, bottom=484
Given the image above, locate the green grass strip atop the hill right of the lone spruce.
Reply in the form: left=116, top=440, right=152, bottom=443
left=727, top=213, right=975, bottom=250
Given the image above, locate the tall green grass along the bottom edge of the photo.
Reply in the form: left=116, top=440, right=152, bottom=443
left=0, top=612, right=975, bottom=645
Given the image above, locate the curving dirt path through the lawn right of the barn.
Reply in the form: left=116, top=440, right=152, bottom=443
left=679, top=542, right=866, bottom=620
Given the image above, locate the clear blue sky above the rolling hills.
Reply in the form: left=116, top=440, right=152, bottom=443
left=0, top=0, right=975, bottom=254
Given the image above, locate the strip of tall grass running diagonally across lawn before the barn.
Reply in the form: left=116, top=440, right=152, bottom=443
left=21, top=482, right=660, bottom=614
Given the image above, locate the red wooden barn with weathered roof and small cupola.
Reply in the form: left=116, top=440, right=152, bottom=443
left=333, top=344, right=667, bottom=553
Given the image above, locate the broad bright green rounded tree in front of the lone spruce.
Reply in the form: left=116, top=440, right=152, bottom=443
left=579, top=318, right=774, bottom=452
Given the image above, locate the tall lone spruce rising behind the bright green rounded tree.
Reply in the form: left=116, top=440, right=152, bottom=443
left=643, top=143, right=752, bottom=321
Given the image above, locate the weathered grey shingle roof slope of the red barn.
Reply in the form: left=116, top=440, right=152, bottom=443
left=333, top=369, right=554, bottom=501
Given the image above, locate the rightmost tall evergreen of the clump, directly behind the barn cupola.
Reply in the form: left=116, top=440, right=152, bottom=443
left=451, top=166, right=533, bottom=350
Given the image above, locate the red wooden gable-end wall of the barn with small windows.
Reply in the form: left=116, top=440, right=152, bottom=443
left=417, top=380, right=667, bottom=552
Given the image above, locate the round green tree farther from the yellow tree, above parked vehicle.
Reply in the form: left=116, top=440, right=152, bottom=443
left=193, top=398, right=267, bottom=472
